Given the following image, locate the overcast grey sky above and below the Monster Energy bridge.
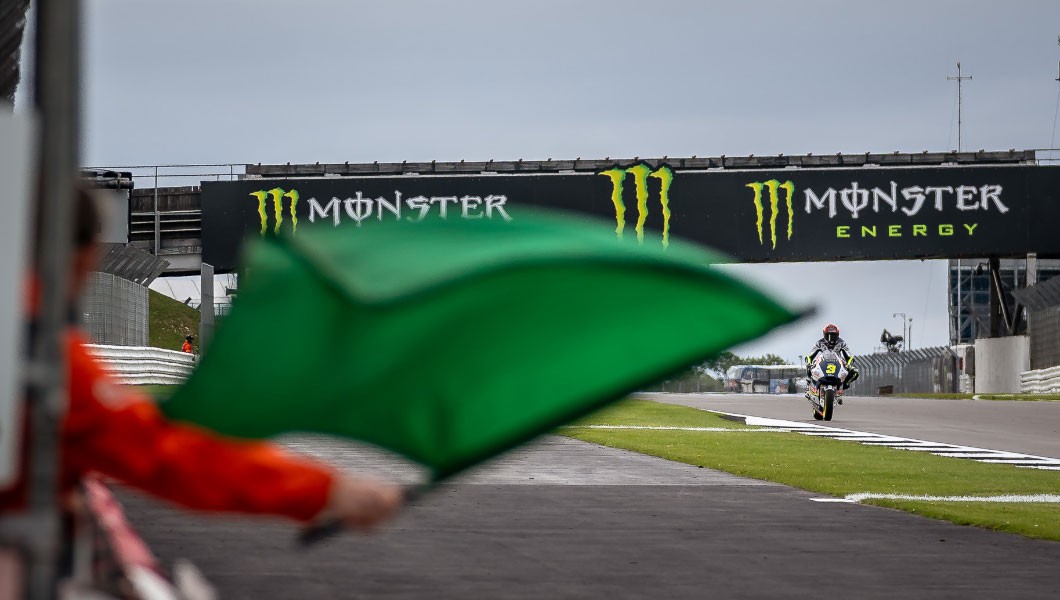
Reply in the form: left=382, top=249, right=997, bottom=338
left=16, top=0, right=1060, bottom=358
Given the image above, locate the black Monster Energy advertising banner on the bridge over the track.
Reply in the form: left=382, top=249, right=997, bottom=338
left=202, top=163, right=1060, bottom=269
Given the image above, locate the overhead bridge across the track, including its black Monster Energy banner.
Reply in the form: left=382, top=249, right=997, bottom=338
left=89, top=149, right=1060, bottom=341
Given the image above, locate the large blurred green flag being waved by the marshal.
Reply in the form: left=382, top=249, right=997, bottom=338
left=162, top=214, right=796, bottom=480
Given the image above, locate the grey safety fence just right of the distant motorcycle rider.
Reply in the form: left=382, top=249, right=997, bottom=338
left=852, top=346, right=958, bottom=395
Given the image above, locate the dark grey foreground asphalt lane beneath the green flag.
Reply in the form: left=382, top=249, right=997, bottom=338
left=120, top=426, right=1060, bottom=600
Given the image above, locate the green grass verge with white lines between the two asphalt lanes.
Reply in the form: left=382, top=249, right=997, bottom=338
left=558, top=400, right=1060, bottom=541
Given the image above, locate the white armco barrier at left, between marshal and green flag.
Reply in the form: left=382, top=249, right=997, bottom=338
left=88, top=343, right=195, bottom=386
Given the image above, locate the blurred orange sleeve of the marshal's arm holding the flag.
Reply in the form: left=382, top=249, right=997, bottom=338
left=61, top=333, right=334, bottom=522
